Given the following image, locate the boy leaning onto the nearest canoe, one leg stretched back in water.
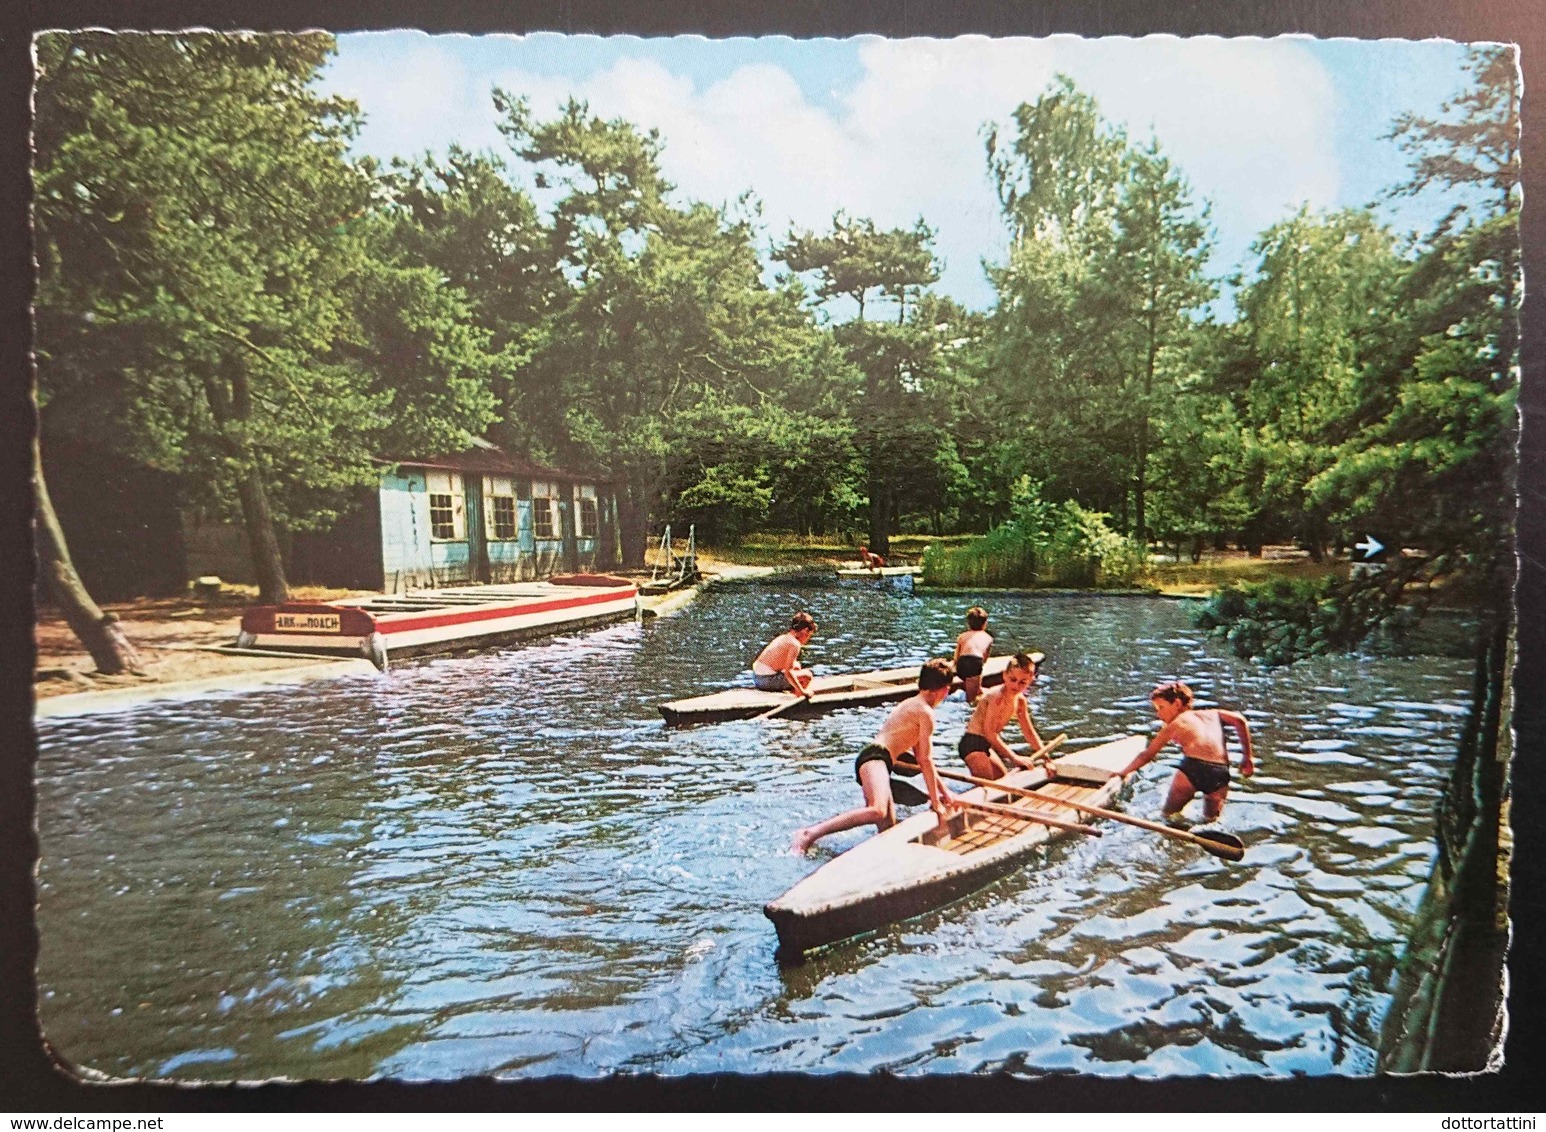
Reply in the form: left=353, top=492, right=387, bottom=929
left=793, top=660, right=955, bottom=854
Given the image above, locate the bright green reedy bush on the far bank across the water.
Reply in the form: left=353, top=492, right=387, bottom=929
left=923, top=478, right=1144, bottom=589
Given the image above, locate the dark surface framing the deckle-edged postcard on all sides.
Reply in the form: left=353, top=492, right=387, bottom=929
left=0, top=0, right=1546, bottom=1121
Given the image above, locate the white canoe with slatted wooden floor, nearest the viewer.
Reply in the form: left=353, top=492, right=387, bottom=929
left=762, top=736, right=1146, bottom=962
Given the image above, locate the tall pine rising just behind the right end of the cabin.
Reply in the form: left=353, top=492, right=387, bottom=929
left=495, top=91, right=850, bottom=564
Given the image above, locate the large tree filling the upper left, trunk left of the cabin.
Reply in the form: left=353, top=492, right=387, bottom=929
left=34, top=32, right=492, bottom=602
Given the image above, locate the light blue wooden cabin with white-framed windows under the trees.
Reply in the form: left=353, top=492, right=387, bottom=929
left=291, top=442, right=618, bottom=594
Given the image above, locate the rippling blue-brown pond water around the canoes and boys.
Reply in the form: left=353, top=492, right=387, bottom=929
left=27, top=585, right=1469, bottom=1081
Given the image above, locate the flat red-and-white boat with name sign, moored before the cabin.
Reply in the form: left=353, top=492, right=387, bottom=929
left=237, top=574, right=638, bottom=671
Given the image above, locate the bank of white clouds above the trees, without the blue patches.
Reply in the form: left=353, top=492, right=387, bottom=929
left=331, top=37, right=1339, bottom=305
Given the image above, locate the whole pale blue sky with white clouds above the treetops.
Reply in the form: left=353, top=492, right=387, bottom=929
left=322, top=31, right=1490, bottom=317
